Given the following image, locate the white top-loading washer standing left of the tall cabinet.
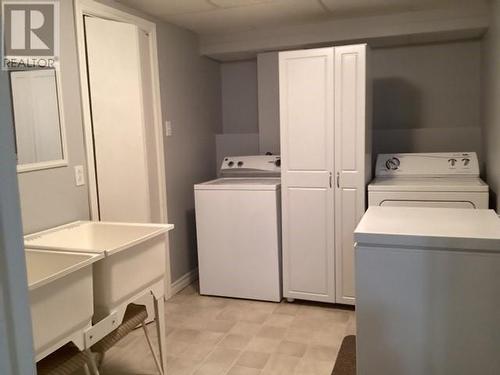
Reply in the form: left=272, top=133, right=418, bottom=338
left=194, top=156, right=281, bottom=302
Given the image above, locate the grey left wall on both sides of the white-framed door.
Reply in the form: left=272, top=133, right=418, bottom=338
left=9, top=0, right=222, bottom=280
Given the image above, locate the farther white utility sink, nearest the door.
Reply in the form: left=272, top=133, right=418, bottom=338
left=25, top=221, right=174, bottom=321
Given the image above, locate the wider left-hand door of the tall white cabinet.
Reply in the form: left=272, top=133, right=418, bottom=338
left=279, top=48, right=335, bottom=302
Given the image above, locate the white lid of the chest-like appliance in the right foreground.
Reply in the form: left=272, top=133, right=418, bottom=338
left=354, top=206, right=500, bottom=252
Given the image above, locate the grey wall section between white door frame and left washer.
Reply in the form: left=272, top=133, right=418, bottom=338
left=157, top=24, right=222, bottom=280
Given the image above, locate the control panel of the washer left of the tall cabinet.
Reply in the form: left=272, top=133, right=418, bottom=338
left=220, top=155, right=281, bottom=176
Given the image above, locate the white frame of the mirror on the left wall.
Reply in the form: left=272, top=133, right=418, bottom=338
left=9, top=62, right=69, bottom=173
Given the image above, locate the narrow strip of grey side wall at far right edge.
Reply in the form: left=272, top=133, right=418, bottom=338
left=482, top=0, right=500, bottom=212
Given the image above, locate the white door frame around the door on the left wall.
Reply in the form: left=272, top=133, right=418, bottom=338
left=74, top=0, right=172, bottom=299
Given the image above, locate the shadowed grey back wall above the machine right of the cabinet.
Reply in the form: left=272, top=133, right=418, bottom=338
left=371, top=41, right=482, bottom=157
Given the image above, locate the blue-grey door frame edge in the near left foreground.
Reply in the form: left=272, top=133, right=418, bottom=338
left=0, top=72, right=35, bottom=374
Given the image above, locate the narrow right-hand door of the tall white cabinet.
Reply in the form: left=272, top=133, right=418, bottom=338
left=335, top=45, right=366, bottom=304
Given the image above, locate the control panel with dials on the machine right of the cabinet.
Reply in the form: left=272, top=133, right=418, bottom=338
left=375, top=152, right=479, bottom=177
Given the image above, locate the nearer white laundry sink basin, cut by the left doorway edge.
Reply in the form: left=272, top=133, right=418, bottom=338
left=25, top=249, right=103, bottom=360
